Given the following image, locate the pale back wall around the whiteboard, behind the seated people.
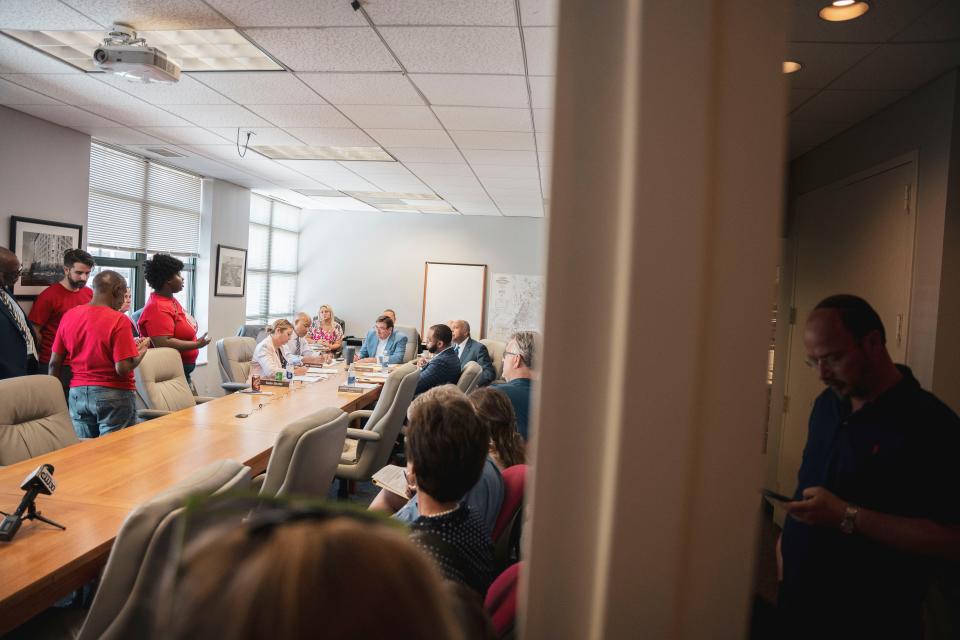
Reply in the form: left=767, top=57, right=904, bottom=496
left=297, top=211, right=547, bottom=338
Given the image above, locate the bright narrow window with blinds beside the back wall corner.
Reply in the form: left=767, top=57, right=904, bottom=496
left=247, top=195, right=300, bottom=324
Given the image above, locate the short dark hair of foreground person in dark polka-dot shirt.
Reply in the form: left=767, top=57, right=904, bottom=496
left=406, top=384, right=490, bottom=502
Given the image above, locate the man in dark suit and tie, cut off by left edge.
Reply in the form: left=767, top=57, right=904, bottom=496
left=0, top=247, right=38, bottom=379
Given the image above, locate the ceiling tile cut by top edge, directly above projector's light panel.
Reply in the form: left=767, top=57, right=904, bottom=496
left=62, top=0, right=233, bottom=31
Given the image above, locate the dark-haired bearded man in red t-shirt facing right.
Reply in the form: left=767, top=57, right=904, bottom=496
left=27, top=249, right=95, bottom=395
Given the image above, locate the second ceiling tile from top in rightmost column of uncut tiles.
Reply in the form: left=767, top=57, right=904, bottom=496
left=380, top=27, right=524, bottom=74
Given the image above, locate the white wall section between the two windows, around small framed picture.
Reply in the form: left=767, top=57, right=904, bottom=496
left=193, top=179, right=250, bottom=396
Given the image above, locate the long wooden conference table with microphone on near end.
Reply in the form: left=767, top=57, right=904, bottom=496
left=0, top=365, right=380, bottom=634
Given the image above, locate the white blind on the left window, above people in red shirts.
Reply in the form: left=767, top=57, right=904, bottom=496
left=87, top=144, right=203, bottom=256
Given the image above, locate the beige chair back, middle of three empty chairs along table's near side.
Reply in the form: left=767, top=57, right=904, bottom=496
left=260, top=407, right=350, bottom=497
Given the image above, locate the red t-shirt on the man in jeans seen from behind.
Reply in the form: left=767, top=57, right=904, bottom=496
left=53, top=304, right=137, bottom=390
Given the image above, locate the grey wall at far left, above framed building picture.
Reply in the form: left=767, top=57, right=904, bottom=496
left=0, top=107, right=90, bottom=309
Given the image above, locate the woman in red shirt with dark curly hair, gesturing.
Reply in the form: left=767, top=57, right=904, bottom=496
left=138, top=253, right=210, bottom=382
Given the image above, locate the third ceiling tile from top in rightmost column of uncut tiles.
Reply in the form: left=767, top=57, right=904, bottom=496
left=410, top=74, right=528, bottom=108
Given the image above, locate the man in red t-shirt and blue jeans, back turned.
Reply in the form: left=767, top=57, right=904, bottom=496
left=50, top=271, right=150, bottom=438
